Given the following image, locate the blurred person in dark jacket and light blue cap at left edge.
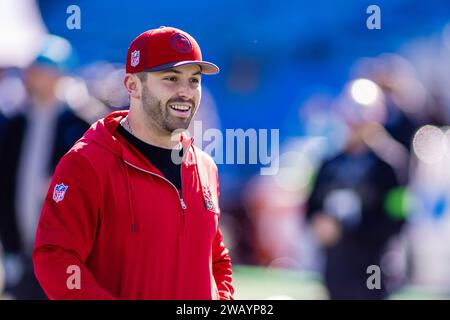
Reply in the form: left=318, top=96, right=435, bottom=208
left=0, top=35, right=89, bottom=299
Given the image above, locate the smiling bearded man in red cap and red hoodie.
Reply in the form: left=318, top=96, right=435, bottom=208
left=33, top=27, right=234, bottom=300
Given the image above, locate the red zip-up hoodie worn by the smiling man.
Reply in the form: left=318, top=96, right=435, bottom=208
left=33, top=111, right=234, bottom=300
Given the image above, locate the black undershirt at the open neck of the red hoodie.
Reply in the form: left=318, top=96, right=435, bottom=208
left=117, top=125, right=183, bottom=190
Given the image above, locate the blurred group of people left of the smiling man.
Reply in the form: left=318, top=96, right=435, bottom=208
left=0, top=35, right=127, bottom=299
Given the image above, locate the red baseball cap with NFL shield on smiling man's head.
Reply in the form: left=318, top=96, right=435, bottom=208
left=126, top=27, right=219, bottom=74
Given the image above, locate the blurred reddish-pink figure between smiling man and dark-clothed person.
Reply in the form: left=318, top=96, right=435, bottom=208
left=242, top=171, right=300, bottom=269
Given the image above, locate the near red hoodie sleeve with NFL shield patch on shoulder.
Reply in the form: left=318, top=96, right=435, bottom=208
left=33, top=150, right=114, bottom=300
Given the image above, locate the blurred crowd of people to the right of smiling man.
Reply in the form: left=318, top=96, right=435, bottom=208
left=237, top=33, right=450, bottom=299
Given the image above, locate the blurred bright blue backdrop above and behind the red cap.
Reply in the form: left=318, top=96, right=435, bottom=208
left=38, top=0, right=450, bottom=188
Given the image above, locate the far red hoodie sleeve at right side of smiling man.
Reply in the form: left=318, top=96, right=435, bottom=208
left=213, top=172, right=234, bottom=300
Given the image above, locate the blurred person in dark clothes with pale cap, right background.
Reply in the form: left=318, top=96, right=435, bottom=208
left=306, top=95, right=403, bottom=299
